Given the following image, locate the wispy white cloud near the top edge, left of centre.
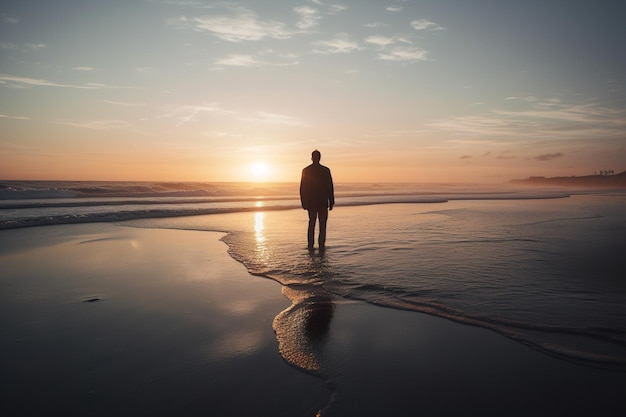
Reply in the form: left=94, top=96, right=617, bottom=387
left=175, top=8, right=293, bottom=42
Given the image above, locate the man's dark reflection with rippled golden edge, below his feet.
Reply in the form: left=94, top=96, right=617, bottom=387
left=273, top=252, right=335, bottom=371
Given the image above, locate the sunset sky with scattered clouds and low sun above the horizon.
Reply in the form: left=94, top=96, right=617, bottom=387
left=0, top=0, right=626, bottom=183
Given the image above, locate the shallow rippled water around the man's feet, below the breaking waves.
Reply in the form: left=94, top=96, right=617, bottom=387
left=129, top=195, right=626, bottom=368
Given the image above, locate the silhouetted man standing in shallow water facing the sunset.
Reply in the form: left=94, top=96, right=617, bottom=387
left=300, top=150, right=335, bottom=250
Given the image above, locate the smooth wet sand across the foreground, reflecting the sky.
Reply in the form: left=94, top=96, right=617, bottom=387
left=0, top=219, right=626, bottom=416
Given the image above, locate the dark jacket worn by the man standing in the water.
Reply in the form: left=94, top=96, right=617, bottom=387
left=300, top=163, right=335, bottom=210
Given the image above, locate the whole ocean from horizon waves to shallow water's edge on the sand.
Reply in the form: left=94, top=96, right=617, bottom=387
left=0, top=181, right=626, bottom=371
